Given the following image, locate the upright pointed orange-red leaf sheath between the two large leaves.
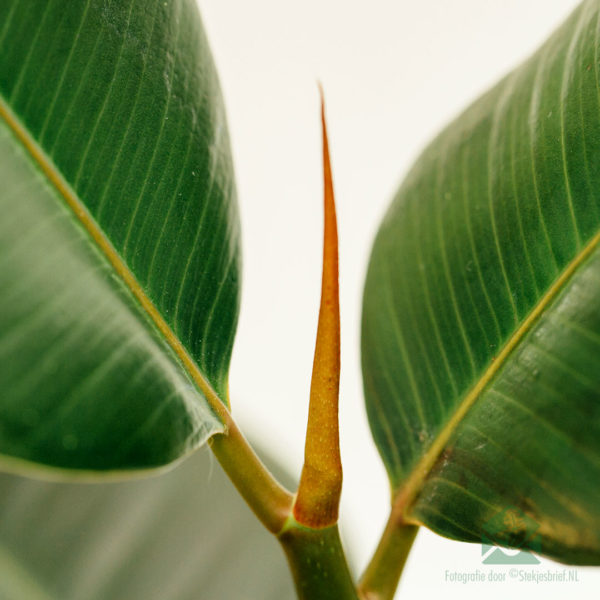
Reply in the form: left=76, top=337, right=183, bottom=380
left=294, top=86, right=342, bottom=528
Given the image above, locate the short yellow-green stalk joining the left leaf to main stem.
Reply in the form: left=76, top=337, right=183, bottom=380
left=208, top=411, right=294, bottom=534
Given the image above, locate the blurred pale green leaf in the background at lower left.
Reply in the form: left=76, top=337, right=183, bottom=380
left=0, top=451, right=294, bottom=600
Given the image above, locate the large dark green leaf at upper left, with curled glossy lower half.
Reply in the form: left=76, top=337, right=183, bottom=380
left=0, top=0, right=240, bottom=470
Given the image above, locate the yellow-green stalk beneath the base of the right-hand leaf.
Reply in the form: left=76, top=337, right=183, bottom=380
left=358, top=505, right=418, bottom=600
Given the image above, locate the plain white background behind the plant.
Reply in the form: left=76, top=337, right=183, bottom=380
left=198, top=0, right=600, bottom=600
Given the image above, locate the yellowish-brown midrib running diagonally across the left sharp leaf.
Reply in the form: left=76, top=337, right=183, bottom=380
left=0, top=95, right=230, bottom=427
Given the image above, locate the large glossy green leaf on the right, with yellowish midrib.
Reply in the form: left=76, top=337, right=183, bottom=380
left=363, top=0, right=600, bottom=564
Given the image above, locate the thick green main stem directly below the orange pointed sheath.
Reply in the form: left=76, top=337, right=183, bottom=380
left=278, top=517, right=358, bottom=600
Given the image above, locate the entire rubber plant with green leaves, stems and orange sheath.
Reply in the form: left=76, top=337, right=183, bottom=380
left=0, top=0, right=600, bottom=600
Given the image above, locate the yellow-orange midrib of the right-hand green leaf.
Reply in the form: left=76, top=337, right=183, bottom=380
left=392, top=223, right=600, bottom=525
